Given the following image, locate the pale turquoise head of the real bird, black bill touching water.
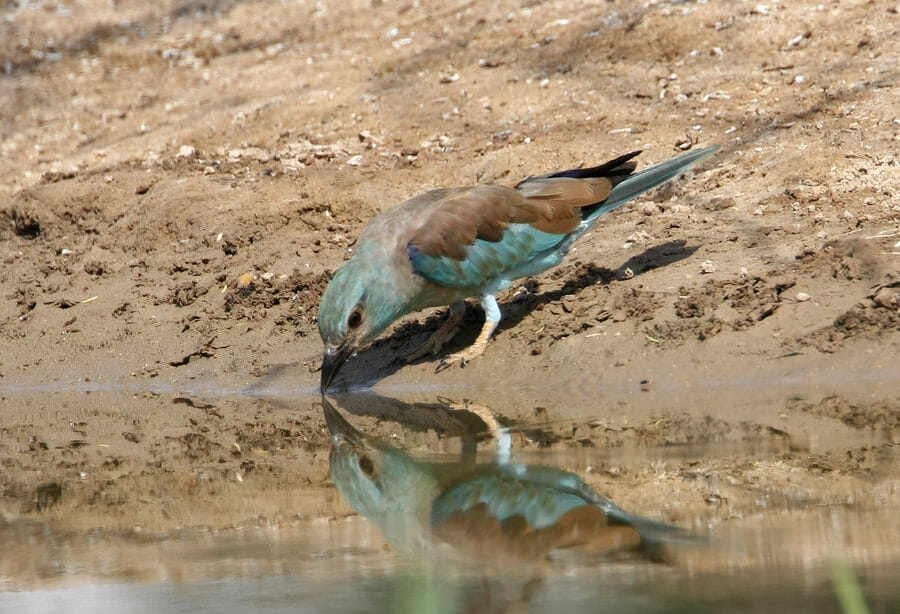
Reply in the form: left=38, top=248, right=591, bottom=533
left=319, top=256, right=405, bottom=393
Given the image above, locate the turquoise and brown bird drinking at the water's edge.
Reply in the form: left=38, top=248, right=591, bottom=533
left=318, top=146, right=719, bottom=393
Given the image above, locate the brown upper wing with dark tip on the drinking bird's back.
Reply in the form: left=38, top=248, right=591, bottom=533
left=410, top=152, right=638, bottom=261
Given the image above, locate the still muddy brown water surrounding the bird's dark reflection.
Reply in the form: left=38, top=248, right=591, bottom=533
left=0, top=390, right=900, bottom=613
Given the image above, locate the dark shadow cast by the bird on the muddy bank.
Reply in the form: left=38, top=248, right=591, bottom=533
left=332, top=240, right=699, bottom=390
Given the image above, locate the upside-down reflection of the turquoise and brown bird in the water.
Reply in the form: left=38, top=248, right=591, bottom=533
left=322, top=396, right=701, bottom=562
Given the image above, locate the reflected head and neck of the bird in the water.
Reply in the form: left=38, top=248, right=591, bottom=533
left=322, top=397, right=436, bottom=547
